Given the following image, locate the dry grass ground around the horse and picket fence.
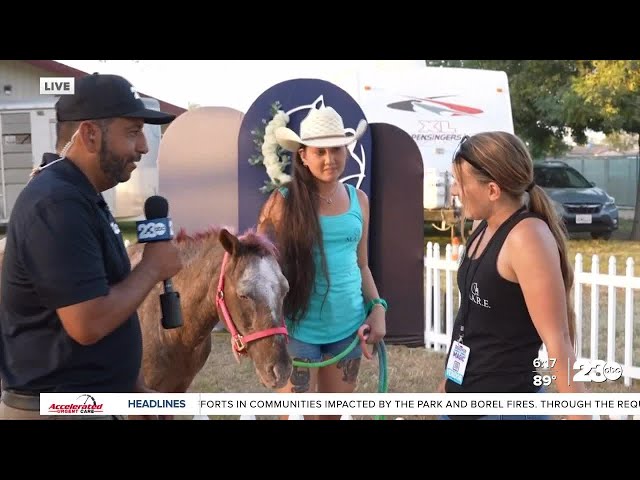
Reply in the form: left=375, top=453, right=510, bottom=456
left=181, top=222, right=640, bottom=420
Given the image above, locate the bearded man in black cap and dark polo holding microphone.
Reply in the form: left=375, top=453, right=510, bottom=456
left=0, top=74, right=182, bottom=419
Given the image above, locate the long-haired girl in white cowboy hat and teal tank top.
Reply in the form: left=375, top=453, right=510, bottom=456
left=258, top=107, right=386, bottom=418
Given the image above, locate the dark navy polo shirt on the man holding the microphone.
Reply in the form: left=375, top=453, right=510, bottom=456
left=0, top=157, right=142, bottom=392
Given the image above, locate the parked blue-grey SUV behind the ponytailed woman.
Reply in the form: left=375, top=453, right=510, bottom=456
left=533, top=161, right=618, bottom=240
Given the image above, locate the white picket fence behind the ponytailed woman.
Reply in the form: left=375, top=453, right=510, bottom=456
left=424, top=242, right=640, bottom=386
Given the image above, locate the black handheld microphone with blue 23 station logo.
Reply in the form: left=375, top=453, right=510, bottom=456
left=136, top=195, right=183, bottom=329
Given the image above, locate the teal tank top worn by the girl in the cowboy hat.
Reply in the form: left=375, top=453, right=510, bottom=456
left=280, top=183, right=365, bottom=344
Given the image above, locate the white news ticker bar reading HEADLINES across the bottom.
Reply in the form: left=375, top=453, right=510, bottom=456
left=40, top=393, right=640, bottom=416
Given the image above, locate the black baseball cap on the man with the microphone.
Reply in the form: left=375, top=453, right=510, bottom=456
left=56, top=73, right=176, bottom=125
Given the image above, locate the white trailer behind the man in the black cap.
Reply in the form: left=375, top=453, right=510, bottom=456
left=0, top=95, right=161, bottom=225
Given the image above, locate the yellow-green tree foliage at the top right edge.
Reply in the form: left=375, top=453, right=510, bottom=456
left=573, top=60, right=640, bottom=240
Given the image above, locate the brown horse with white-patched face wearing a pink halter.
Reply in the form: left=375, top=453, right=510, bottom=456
left=0, top=227, right=293, bottom=393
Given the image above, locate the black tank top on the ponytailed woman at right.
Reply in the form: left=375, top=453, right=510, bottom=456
left=445, top=207, right=542, bottom=393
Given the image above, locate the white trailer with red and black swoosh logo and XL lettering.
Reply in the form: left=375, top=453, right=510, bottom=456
left=356, top=66, right=513, bottom=226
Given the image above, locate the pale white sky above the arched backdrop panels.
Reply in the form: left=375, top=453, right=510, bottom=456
left=56, top=60, right=424, bottom=112
